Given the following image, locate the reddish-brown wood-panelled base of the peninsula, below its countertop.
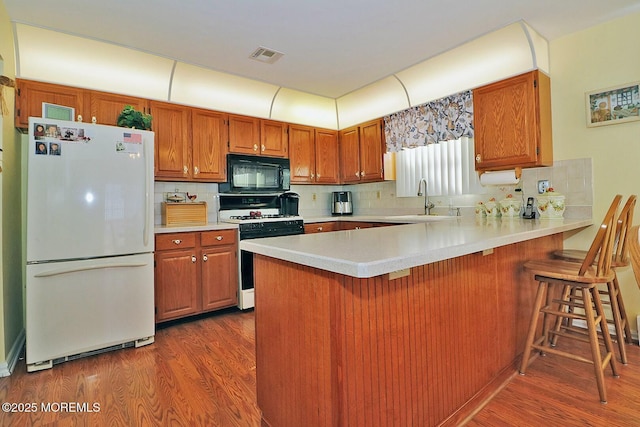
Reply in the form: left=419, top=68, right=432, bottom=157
left=254, top=234, right=562, bottom=427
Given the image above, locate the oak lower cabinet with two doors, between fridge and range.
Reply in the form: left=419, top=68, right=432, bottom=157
left=155, top=230, right=238, bottom=322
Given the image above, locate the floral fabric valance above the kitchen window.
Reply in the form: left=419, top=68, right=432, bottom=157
left=384, top=91, right=473, bottom=151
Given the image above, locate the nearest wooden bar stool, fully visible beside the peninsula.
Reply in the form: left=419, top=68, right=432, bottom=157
left=520, top=195, right=622, bottom=403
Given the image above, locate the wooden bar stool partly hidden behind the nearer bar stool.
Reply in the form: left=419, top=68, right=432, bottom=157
left=552, top=195, right=637, bottom=365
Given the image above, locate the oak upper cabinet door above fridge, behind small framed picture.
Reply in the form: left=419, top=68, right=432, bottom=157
left=15, top=79, right=90, bottom=128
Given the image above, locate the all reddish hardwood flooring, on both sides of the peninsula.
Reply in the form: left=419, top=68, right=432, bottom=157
left=0, top=310, right=640, bottom=427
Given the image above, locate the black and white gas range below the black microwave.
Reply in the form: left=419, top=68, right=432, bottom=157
left=218, top=193, right=304, bottom=310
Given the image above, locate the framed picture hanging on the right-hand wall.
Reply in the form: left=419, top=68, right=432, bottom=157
left=586, top=82, right=640, bottom=127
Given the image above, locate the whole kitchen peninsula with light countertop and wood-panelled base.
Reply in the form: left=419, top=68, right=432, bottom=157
left=240, top=217, right=592, bottom=427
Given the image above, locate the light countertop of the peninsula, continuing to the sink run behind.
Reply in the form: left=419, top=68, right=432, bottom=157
left=240, top=216, right=593, bottom=277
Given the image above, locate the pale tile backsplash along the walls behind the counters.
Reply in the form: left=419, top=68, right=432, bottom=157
left=154, top=158, right=593, bottom=225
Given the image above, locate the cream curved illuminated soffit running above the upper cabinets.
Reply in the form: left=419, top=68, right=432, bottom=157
left=14, top=21, right=549, bottom=129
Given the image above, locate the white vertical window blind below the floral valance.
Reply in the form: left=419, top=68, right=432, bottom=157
left=396, top=137, right=484, bottom=197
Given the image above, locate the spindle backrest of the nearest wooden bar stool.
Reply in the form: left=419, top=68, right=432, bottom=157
left=578, top=194, right=622, bottom=277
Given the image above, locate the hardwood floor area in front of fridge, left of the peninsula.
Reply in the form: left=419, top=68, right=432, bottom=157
left=0, top=311, right=260, bottom=426
